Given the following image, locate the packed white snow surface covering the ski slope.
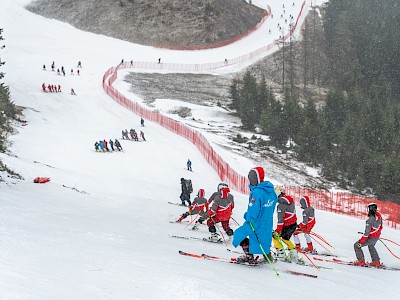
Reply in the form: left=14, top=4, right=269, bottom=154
left=0, top=0, right=400, bottom=300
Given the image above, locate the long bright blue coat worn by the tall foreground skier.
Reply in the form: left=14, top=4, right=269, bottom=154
left=232, top=181, right=278, bottom=254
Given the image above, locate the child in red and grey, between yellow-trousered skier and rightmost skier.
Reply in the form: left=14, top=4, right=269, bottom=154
left=293, top=196, right=316, bottom=252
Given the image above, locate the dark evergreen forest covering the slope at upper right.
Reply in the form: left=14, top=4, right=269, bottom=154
left=230, top=0, right=400, bottom=202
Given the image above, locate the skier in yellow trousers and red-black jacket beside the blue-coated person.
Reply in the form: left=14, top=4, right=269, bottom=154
left=272, top=187, right=299, bottom=262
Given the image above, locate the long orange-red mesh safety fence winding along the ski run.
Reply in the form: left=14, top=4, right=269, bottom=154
left=103, top=1, right=400, bottom=229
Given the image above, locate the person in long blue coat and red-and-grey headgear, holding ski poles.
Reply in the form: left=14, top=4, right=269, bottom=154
left=232, top=167, right=278, bottom=263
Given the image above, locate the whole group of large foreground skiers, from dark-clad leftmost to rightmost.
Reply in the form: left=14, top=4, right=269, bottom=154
left=173, top=167, right=382, bottom=268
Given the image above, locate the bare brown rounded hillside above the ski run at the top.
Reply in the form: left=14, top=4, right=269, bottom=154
left=27, top=0, right=263, bottom=46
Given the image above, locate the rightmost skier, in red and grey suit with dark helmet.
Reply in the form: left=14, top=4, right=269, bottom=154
left=354, top=203, right=382, bottom=268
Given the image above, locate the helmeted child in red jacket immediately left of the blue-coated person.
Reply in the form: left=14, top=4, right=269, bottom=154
left=207, top=187, right=235, bottom=242
